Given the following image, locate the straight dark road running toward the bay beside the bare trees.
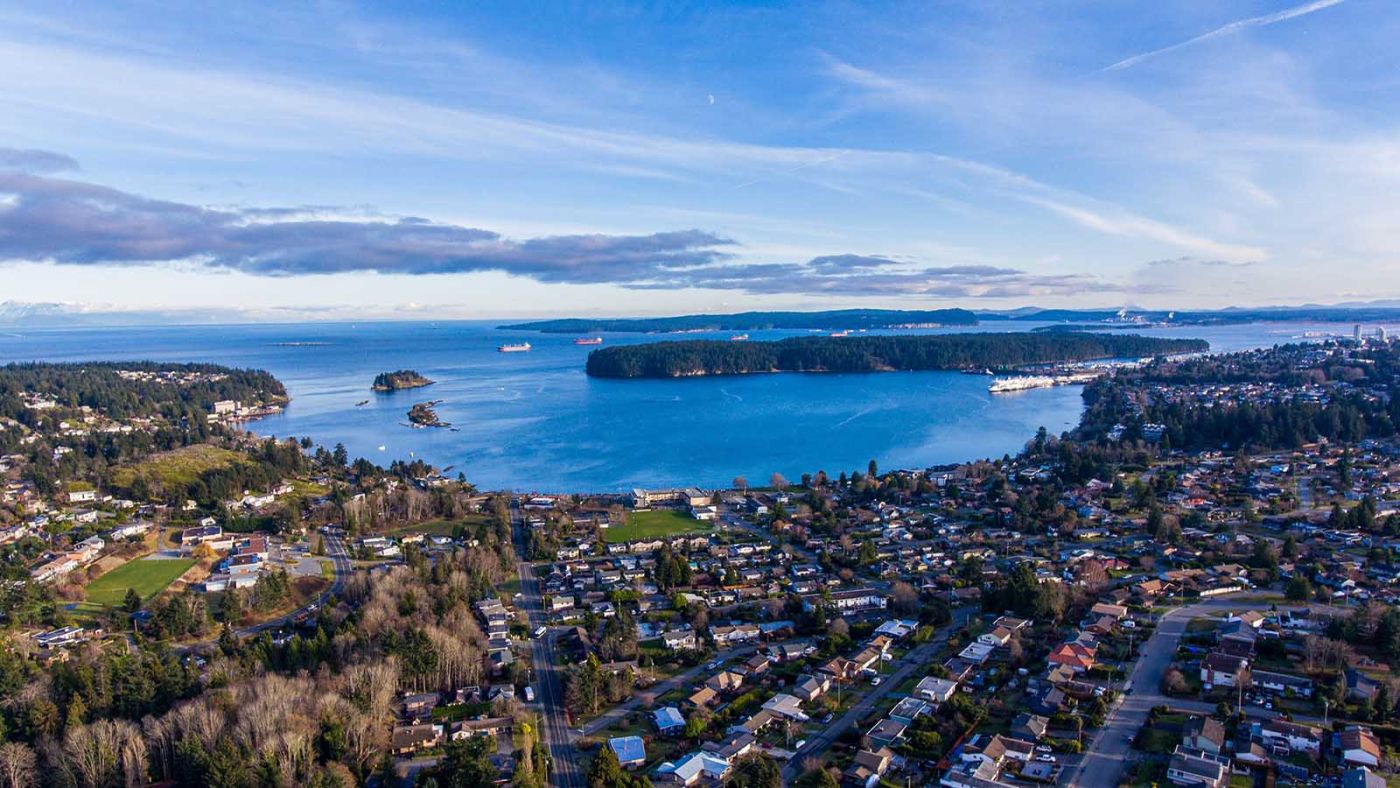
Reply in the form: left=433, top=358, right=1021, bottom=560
left=511, top=501, right=588, bottom=788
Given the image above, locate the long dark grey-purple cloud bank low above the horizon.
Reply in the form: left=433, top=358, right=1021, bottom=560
left=0, top=148, right=1117, bottom=298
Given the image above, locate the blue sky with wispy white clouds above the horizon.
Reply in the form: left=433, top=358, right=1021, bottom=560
left=0, top=0, right=1400, bottom=319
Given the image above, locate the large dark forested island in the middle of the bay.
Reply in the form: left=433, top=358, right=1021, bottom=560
left=588, top=332, right=1210, bottom=378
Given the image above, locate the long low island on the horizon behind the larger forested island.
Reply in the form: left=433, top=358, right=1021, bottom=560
left=498, top=309, right=977, bottom=335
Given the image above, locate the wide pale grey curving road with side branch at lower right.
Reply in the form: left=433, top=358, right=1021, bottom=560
left=1067, top=599, right=1268, bottom=785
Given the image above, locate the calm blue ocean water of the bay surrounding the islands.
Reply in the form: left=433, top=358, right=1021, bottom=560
left=0, top=322, right=1377, bottom=493
